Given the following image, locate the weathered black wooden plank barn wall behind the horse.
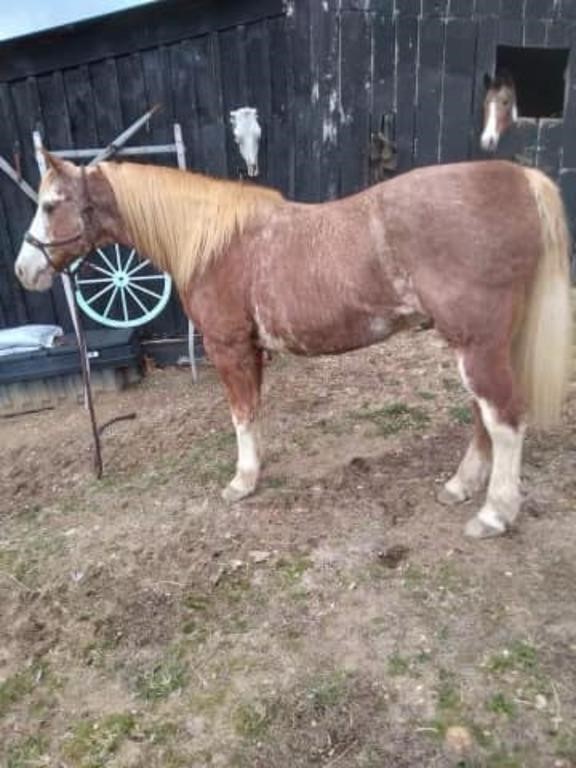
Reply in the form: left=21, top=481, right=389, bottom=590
left=0, top=0, right=576, bottom=335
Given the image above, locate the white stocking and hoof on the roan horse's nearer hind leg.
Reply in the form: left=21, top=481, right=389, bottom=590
left=466, top=399, right=526, bottom=537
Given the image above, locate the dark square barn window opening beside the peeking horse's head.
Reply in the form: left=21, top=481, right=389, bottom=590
left=496, top=45, right=570, bottom=118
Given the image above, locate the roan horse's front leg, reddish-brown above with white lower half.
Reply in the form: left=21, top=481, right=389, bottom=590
left=205, top=341, right=262, bottom=502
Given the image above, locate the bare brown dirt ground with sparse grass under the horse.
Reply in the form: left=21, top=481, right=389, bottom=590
left=0, top=332, right=576, bottom=768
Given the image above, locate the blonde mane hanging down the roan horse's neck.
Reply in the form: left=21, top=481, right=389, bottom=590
left=101, top=163, right=282, bottom=289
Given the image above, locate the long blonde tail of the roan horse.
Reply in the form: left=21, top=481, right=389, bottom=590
left=513, top=168, right=572, bottom=428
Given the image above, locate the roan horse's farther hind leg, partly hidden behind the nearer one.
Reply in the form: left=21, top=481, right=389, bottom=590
left=438, top=400, right=492, bottom=505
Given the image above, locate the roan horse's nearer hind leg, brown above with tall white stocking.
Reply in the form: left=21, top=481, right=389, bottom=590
left=462, top=349, right=525, bottom=538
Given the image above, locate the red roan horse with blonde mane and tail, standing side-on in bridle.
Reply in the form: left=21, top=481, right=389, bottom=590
left=16, top=156, right=571, bottom=537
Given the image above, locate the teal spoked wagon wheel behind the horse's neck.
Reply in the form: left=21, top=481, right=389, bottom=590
left=74, top=244, right=172, bottom=328
